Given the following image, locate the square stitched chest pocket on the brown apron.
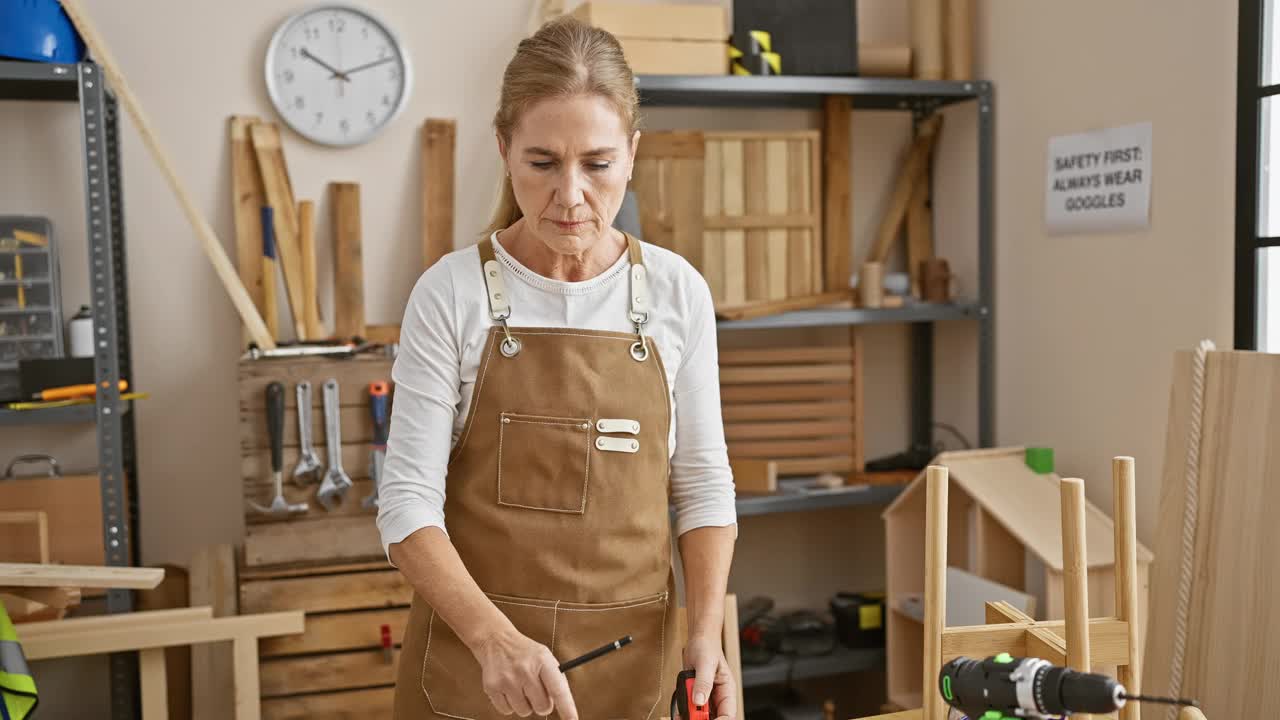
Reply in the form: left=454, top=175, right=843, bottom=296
left=498, top=413, right=591, bottom=515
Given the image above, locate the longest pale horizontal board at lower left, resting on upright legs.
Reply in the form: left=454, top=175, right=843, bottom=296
left=22, top=610, right=302, bottom=671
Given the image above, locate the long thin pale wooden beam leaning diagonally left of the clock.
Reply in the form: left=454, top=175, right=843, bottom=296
left=63, top=0, right=275, bottom=350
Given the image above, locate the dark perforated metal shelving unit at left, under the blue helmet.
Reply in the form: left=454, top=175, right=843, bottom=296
left=0, top=60, right=138, bottom=720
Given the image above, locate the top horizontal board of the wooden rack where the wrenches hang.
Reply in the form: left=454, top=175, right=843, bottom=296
left=239, top=356, right=392, bottom=411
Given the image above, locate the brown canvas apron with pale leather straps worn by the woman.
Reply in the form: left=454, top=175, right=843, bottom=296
left=396, top=236, right=682, bottom=720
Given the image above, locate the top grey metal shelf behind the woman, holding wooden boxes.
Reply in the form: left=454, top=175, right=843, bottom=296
left=636, top=76, right=989, bottom=110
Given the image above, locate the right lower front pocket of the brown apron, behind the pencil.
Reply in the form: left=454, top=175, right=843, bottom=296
left=552, top=592, right=677, bottom=720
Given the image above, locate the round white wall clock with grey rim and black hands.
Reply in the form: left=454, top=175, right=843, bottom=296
left=266, top=5, right=412, bottom=146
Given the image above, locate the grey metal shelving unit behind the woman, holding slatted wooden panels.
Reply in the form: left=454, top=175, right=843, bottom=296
left=636, top=76, right=995, bottom=687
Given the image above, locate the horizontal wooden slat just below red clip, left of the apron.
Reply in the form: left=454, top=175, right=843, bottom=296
left=261, top=650, right=399, bottom=698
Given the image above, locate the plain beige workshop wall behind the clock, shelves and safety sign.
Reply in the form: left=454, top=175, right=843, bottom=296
left=0, top=0, right=1235, bottom=707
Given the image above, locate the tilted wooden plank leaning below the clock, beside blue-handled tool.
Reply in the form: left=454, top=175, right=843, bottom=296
left=250, top=123, right=307, bottom=338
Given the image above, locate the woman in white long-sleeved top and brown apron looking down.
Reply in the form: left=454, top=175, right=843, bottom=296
left=378, top=12, right=737, bottom=720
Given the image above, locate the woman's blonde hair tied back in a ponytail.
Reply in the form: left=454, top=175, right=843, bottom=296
left=484, top=15, right=640, bottom=237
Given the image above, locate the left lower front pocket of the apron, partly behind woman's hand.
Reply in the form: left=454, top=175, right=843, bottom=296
left=422, top=594, right=558, bottom=720
